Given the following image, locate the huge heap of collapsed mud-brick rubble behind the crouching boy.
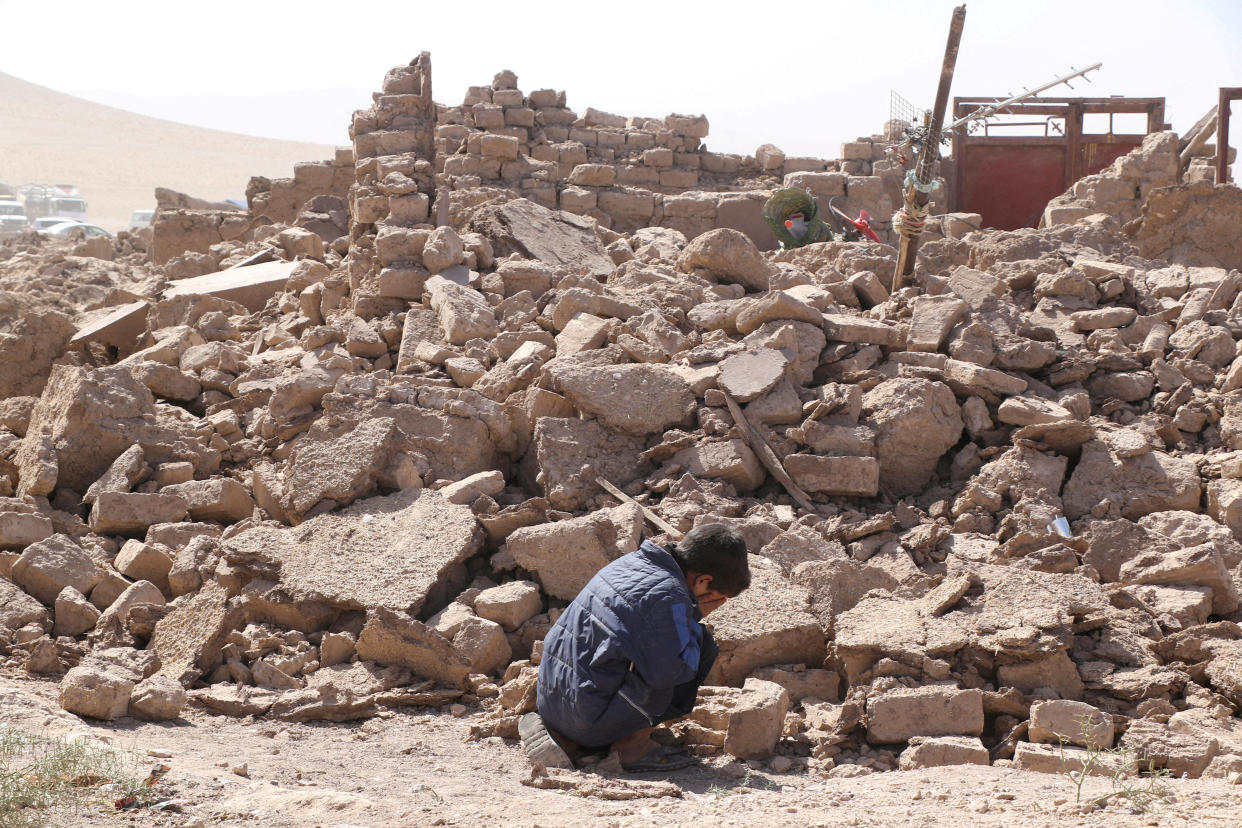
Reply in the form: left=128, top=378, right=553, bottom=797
left=0, top=56, right=1242, bottom=776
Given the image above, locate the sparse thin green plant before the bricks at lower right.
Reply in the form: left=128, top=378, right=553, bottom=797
left=1059, top=716, right=1172, bottom=813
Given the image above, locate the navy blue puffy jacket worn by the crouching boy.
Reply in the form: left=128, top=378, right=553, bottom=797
left=537, top=541, right=714, bottom=747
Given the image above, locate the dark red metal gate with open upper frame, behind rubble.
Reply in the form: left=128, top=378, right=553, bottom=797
left=949, top=98, right=1169, bottom=230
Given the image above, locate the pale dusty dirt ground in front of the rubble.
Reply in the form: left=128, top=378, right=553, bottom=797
left=0, top=670, right=1242, bottom=828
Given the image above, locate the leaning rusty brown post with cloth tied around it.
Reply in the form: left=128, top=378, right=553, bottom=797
left=893, top=5, right=966, bottom=293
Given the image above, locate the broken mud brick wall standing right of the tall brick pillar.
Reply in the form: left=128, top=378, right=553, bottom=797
left=436, top=72, right=919, bottom=248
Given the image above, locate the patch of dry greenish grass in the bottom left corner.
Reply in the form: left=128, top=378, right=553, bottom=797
left=0, top=725, right=154, bottom=828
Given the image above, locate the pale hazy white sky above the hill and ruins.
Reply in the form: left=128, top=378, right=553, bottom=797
left=0, top=0, right=1242, bottom=158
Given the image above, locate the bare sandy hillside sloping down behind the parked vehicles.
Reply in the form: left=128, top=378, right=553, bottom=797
left=0, top=73, right=347, bottom=230
